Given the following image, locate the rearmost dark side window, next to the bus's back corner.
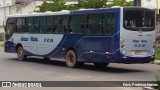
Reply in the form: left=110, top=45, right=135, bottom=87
left=105, top=12, right=116, bottom=34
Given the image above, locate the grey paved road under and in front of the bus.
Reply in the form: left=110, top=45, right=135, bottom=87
left=0, top=47, right=160, bottom=90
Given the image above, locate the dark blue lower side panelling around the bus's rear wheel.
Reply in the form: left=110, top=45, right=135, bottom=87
left=47, top=34, right=112, bottom=62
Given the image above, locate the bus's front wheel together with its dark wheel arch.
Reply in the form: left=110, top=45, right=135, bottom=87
left=16, top=43, right=27, bottom=61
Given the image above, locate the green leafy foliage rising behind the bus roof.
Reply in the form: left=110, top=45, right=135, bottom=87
left=37, top=0, right=134, bottom=12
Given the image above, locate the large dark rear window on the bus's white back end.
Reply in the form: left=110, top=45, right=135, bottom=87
left=123, top=8, right=155, bottom=31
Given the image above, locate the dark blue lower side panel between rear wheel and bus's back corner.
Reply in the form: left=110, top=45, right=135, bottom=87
left=77, top=36, right=112, bottom=62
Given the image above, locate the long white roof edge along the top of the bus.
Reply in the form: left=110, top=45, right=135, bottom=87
left=8, top=6, right=153, bottom=18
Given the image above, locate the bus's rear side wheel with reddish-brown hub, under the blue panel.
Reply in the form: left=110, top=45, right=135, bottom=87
left=65, top=50, right=77, bottom=68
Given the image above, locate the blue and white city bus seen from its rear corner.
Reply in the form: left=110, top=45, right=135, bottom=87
left=4, top=6, right=156, bottom=68
